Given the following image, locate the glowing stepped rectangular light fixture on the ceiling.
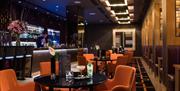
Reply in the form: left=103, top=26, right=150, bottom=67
left=100, top=0, right=134, bottom=24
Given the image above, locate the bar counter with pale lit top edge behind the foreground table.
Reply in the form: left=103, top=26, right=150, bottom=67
left=32, top=48, right=88, bottom=72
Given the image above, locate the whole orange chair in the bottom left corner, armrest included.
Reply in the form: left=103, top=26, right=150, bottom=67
left=0, top=69, right=36, bottom=91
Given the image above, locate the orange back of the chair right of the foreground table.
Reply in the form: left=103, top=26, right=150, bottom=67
left=112, top=65, right=133, bottom=86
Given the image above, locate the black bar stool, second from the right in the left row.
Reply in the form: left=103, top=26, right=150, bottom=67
left=15, top=46, right=26, bottom=80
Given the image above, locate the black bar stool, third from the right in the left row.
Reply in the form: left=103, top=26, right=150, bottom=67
left=3, top=46, right=15, bottom=69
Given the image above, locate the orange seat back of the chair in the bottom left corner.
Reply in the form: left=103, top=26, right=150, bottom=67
left=0, top=69, right=18, bottom=91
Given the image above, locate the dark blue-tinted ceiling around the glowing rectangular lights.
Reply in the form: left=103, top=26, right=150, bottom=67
left=17, top=0, right=151, bottom=24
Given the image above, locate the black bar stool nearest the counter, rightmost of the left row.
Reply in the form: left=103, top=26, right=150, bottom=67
left=25, top=46, right=34, bottom=77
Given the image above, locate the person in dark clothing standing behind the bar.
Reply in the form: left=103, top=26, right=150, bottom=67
left=37, top=30, right=48, bottom=48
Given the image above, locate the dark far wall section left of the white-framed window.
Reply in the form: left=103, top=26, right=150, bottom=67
left=84, top=24, right=114, bottom=49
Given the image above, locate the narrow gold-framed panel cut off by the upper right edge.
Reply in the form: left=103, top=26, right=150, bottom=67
left=175, top=0, right=180, bottom=37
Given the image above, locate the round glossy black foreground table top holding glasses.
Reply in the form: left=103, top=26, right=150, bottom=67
left=34, top=74, right=107, bottom=88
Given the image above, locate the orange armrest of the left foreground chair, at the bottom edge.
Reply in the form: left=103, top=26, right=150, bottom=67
left=18, top=82, right=37, bottom=91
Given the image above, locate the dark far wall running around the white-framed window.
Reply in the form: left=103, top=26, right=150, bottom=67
left=84, top=24, right=141, bottom=56
